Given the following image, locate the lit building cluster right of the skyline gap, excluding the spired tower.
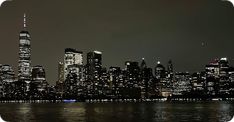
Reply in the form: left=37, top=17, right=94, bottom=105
left=55, top=52, right=234, bottom=100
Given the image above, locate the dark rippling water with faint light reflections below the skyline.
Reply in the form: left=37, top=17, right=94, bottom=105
left=0, top=102, right=234, bottom=122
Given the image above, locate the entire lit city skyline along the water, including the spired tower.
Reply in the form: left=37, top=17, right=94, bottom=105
left=0, top=16, right=234, bottom=100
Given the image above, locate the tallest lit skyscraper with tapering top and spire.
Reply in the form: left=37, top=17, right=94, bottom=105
left=18, top=14, right=31, bottom=83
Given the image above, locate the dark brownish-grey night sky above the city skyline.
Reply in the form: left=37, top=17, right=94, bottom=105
left=0, top=0, right=234, bottom=84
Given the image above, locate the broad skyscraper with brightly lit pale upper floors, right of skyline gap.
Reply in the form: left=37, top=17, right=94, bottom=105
left=63, top=48, right=83, bottom=98
